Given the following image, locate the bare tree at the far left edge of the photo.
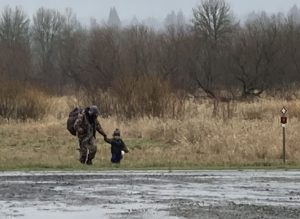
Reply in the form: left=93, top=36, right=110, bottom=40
left=0, top=7, right=31, bottom=81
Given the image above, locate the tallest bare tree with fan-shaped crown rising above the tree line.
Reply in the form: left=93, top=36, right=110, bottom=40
left=189, top=0, right=237, bottom=114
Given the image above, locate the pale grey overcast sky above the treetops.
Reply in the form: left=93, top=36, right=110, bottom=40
left=0, top=0, right=300, bottom=22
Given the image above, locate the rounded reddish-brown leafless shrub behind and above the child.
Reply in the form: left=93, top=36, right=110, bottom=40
left=113, top=75, right=185, bottom=118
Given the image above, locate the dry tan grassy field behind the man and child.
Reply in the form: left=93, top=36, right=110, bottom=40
left=0, top=98, right=300, bottom=170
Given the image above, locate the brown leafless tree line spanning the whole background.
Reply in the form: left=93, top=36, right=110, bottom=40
left=0, top=0, right=300, bottom=105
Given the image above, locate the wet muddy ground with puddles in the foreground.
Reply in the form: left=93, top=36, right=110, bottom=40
left=0, top=171, right=300, bottom=219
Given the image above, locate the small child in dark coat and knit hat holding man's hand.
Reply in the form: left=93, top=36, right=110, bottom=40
left=104, top=129, right=129, bottom=163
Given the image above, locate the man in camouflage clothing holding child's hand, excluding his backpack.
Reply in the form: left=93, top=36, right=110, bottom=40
left=74, top=106, right=106, bottom=165
